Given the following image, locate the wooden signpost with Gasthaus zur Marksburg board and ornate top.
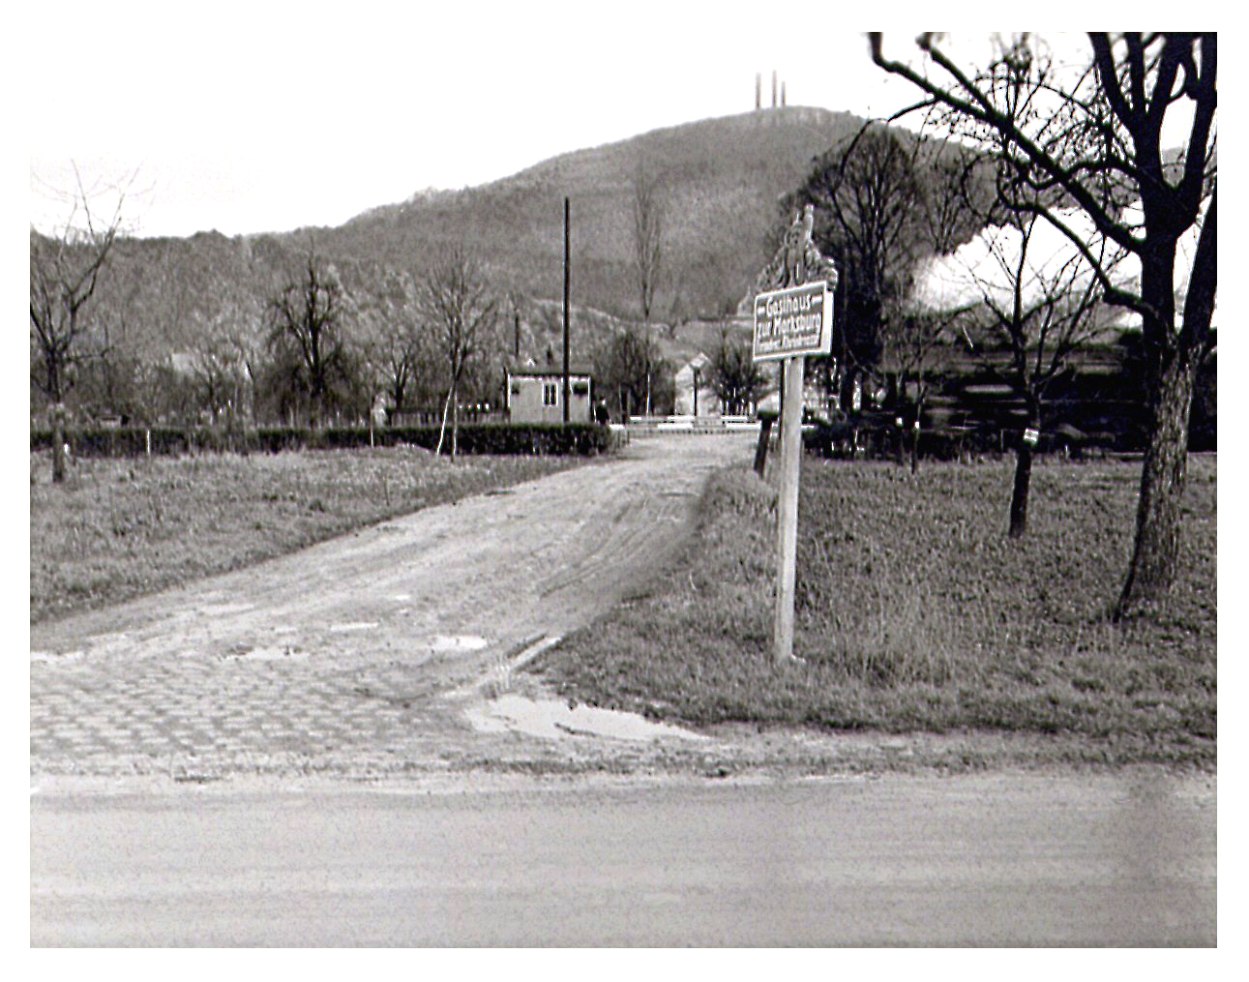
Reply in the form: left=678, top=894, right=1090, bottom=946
left=753, top=205, right=837, bottom=663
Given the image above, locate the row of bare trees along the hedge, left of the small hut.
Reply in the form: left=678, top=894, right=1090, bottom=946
left=30, top=211, right=508, bottom=481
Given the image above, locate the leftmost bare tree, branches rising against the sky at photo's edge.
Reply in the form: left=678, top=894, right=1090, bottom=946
left=30, top=181, right=122, bottom=482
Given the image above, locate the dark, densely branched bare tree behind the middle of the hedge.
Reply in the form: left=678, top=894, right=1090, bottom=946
left=269, top=251, right=347, bottom=429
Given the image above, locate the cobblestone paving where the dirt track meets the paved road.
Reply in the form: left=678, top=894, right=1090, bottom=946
left=30, top=656, right=469, bottom=771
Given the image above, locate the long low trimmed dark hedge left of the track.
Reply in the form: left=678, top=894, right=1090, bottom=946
left=30, top=422, right=618, bottom=457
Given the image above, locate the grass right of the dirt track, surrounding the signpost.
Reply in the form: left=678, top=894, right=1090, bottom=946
left=531, top=457, right=1217, bottom=766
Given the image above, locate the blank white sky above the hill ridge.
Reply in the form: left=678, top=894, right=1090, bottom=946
left=19, top=0, right=1104, bottom=235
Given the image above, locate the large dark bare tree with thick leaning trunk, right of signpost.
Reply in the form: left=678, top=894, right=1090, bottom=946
left=871, top=32, right=1218, bottom=618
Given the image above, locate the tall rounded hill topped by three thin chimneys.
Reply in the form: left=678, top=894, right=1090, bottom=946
left=319, top=106, right=863, bottom=320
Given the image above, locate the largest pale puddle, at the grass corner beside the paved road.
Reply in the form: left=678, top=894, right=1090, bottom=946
left=465, top=693, right=708, bottom=740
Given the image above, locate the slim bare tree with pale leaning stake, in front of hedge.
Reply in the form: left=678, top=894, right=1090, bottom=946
left=421, top=247, right=500, bottom=457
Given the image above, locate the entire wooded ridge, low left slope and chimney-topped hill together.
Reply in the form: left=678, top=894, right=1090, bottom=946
left=41, top=106, right=879, bottom=367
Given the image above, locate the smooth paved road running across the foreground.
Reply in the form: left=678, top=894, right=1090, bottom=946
left=31, top=771, right=1215, bottom=946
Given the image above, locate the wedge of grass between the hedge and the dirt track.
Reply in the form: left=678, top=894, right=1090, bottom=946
left=30, top=447, right=583, bottom=622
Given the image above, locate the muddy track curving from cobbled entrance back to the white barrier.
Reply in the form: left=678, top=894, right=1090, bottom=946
left=31, top=434, right=752, bottom=780
